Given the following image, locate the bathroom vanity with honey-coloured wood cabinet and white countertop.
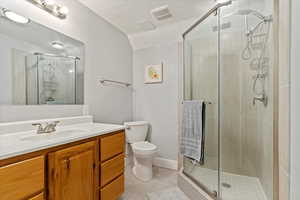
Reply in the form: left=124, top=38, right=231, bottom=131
left=0, top=116, right=125, bottom=200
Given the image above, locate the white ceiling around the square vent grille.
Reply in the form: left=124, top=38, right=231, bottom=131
left=78, top=0, right=214, bottom=35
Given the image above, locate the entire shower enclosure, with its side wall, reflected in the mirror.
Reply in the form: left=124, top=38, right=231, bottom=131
left=26, top=53, right=79, bottom=105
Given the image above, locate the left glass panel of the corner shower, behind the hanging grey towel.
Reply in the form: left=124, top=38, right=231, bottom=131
left=184, top=13, right=219, bottom=197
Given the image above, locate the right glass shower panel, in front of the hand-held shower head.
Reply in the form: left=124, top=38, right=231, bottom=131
left=219, top=0, right=275, bottom=200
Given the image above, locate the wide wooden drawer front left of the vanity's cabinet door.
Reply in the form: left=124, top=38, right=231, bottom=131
left=0, top=156, right=44, bottom=200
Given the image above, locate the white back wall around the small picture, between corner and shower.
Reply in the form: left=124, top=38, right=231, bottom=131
left=133, top=42, right=179, bottom=160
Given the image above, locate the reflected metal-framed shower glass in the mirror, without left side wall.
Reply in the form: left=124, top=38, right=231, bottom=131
left=37, top=55, right=76, bottom=104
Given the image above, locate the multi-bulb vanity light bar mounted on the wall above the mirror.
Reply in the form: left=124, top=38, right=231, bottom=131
left=27, top=0, right=69, bottom=19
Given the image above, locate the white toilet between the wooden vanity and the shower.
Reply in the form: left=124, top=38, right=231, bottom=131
left=124, top=121, right=157, bottom=181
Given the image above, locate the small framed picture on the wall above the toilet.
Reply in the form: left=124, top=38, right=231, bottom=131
left=145, top=64, right=163, bottom=84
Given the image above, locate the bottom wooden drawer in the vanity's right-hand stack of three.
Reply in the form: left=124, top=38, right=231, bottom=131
left=101, top=175, right=124, bottom=200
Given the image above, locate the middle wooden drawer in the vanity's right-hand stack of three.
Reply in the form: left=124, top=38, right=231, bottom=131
left=101, top=154, right=124, bottom=187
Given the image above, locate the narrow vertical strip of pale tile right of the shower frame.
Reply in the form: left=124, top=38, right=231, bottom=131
left=278, top=0, right=291, bottom=200
